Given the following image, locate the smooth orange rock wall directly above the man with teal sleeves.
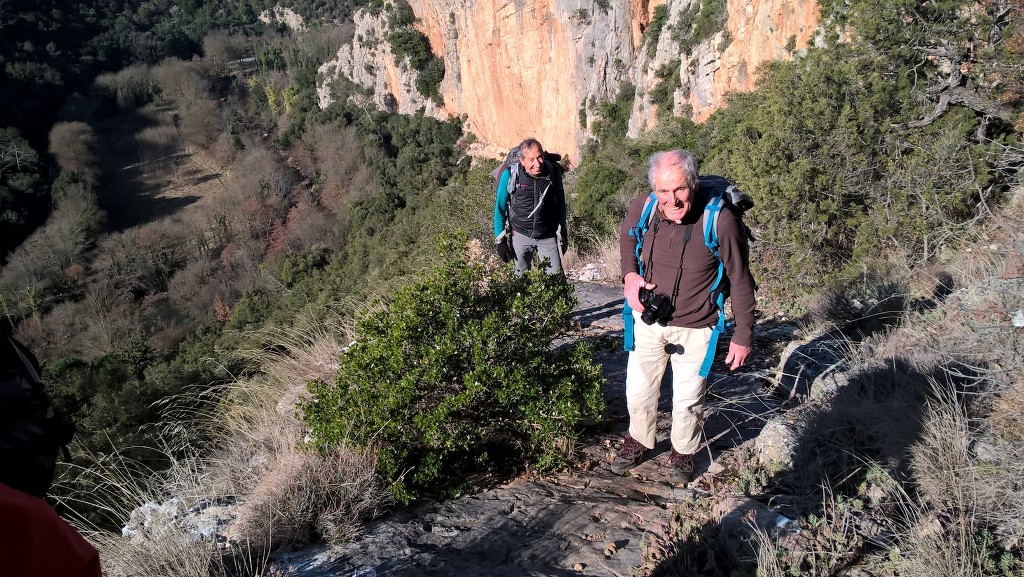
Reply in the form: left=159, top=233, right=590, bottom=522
left=410, top=0, right=580, bottom=161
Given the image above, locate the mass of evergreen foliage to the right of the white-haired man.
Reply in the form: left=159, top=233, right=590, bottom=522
left=577, top=0, right=1024, bottom=295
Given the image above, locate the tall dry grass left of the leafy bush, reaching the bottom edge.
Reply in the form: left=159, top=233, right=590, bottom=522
left=62, top=319, right=390, bottom=577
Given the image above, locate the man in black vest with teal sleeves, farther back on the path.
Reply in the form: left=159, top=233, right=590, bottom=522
left=495, top=138, right=568, bottom=275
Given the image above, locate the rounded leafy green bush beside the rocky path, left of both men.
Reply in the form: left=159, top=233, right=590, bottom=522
left=302, top=243, right=603, bottom=502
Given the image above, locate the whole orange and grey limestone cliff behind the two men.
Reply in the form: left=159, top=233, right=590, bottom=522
left=319, top=0, right=818, bottom=159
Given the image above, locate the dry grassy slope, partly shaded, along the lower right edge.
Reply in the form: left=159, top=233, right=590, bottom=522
left=756, top=190, right=1024, bottom=577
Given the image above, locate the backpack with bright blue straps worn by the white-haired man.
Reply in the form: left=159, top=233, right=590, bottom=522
left=623, top=174, right=757, bottom=378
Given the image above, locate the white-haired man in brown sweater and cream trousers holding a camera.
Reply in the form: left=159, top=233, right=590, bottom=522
left=611, top=150, right=755, bottom=483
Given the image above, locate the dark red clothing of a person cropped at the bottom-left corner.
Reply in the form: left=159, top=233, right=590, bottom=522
left=0, top=483, right=102, bottom=577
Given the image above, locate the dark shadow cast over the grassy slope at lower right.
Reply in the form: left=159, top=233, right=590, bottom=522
left=652, top=358, right=985, bottom=575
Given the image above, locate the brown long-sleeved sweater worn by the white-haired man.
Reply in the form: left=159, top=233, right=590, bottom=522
left=618, top=196, right=755, bottom=346
